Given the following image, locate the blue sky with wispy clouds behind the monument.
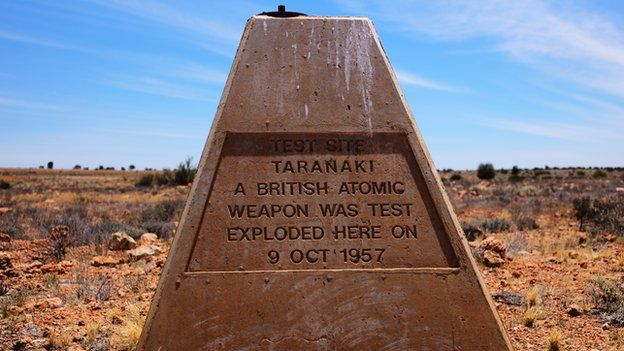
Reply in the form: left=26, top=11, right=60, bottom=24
left=0, top=0, right=624, bottom=169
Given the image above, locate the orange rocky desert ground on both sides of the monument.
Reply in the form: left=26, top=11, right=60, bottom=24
left=0, top=170, right=624, bottom=350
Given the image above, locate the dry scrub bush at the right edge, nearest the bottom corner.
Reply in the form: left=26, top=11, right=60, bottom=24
left=589, top=276, right=624, bottom=327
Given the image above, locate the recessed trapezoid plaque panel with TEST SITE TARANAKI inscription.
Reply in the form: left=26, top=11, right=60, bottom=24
left=188, top=133, right=458, bottom=272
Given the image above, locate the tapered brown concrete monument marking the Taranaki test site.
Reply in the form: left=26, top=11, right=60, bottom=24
left=139, top=16, right=511, bottom=351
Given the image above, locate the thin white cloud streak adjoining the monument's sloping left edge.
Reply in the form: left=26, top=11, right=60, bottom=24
left=107, top=77, right=214, bottom=102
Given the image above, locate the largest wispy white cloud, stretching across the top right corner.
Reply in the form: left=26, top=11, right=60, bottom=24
left=351, top=0, right=624, bottom=98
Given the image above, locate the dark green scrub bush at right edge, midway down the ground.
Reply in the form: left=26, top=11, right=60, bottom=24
left=572, top=194, right=624, bottom=235
